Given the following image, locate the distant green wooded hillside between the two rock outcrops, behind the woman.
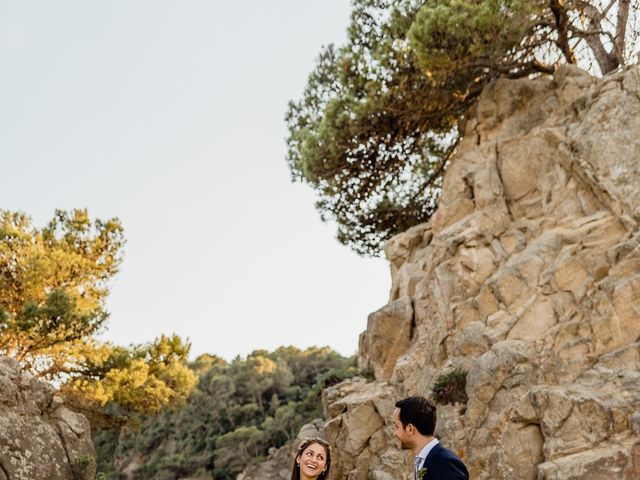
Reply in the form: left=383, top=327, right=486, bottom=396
left=93, top=347, right=357, bottom=480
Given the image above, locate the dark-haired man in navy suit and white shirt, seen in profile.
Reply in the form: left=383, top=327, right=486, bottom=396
left=393, top=396, right=469, bottom=480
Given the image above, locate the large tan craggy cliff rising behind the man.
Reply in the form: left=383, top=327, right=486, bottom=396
left=240, top=67, right=640, bottom=480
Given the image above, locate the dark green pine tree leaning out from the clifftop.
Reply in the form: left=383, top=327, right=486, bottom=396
left=286, top=0, right=640, bottom=255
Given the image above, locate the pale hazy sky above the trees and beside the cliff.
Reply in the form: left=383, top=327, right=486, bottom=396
left=0, top=0, right=391, bottom=359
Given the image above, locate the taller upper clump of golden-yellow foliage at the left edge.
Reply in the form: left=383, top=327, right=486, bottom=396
left=0, top=210, right=124, bottom=376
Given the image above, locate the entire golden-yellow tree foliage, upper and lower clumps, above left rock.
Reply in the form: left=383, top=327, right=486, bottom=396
left=0, top=210, right=196, bottom=418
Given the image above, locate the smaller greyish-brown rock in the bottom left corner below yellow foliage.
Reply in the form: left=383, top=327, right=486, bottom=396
left=0, top=357, right=96, bottom=480
